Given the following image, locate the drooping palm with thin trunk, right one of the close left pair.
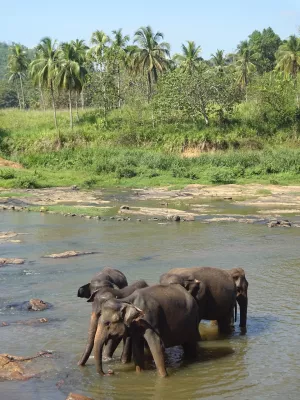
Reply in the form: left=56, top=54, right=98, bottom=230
left=55, top=43, right=86, bottom=129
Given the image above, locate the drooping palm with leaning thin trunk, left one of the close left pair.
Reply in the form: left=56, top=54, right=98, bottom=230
left=29, top=37, right=58, bottom=129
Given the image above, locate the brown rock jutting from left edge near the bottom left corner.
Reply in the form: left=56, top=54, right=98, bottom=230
left=0, top=351, right=52, bottom=381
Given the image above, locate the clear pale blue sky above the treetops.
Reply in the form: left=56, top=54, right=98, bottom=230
left=0, top=0, right=300, bottom=57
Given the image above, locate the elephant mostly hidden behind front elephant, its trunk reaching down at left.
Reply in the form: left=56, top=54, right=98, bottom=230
left=78, top=280, right=148, bottom=366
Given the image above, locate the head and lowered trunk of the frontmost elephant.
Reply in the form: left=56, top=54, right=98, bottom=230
left=94, top=299, right=144, bottom=375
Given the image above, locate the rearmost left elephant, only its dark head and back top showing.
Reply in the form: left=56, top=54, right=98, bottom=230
left=77, top=267, right=128, bottom=299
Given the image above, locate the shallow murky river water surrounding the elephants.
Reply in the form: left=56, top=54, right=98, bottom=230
left=0, top=208, right=300, bottom=400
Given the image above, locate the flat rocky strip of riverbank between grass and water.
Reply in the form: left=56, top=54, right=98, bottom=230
left=0, top=184, right=300, bottom=225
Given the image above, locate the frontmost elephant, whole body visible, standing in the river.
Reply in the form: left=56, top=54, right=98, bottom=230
left=94, top=282, right=201, bottom=377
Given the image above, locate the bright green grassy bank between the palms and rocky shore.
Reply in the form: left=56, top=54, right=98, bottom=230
left=0, top=110, right=300, bottom=188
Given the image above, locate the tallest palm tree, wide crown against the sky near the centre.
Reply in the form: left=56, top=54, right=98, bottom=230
left=131, top=26, right=170, bottom=101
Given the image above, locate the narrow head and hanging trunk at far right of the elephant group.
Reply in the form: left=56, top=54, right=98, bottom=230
left=229, top=268, right=248, bottom=329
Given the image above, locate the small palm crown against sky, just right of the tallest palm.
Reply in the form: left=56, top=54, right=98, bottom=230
left=173, top=40, right=203, bottom=74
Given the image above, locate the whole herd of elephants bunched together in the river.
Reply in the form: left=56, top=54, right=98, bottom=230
left=77, top=267, right=248, bottom=377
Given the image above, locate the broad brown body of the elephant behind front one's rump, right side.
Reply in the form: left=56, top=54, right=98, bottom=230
left=160, top=267, right=240, bottom=333
